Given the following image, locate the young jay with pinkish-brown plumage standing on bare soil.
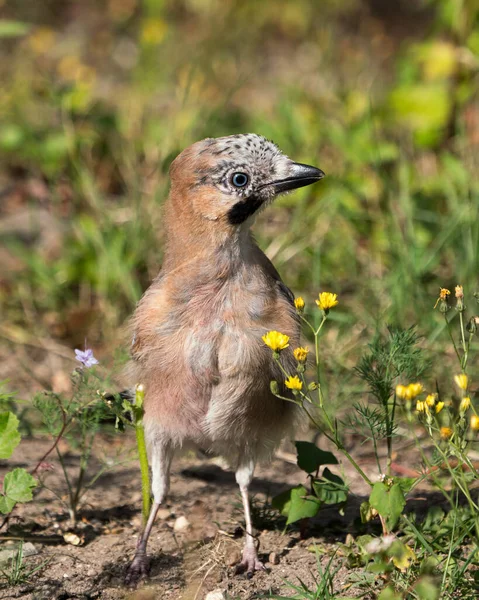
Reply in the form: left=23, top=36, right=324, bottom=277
left=125, top=133, right=324, bottom=584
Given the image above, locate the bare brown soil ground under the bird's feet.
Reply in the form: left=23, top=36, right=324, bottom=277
left=0, top=436, right=434, bottom=600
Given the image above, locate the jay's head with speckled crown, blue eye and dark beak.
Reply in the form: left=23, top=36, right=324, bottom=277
left=170, top=133, right=324, bottom=228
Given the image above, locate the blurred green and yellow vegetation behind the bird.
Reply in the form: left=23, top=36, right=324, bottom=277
left=0, top=0, right=479, bottom=396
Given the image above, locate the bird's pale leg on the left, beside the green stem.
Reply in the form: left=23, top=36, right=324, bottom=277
left=125, top=443, right=173, bottom=585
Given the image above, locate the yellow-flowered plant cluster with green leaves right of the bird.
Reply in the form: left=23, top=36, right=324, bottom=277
left=263, top=286, right=479, bottom=600
